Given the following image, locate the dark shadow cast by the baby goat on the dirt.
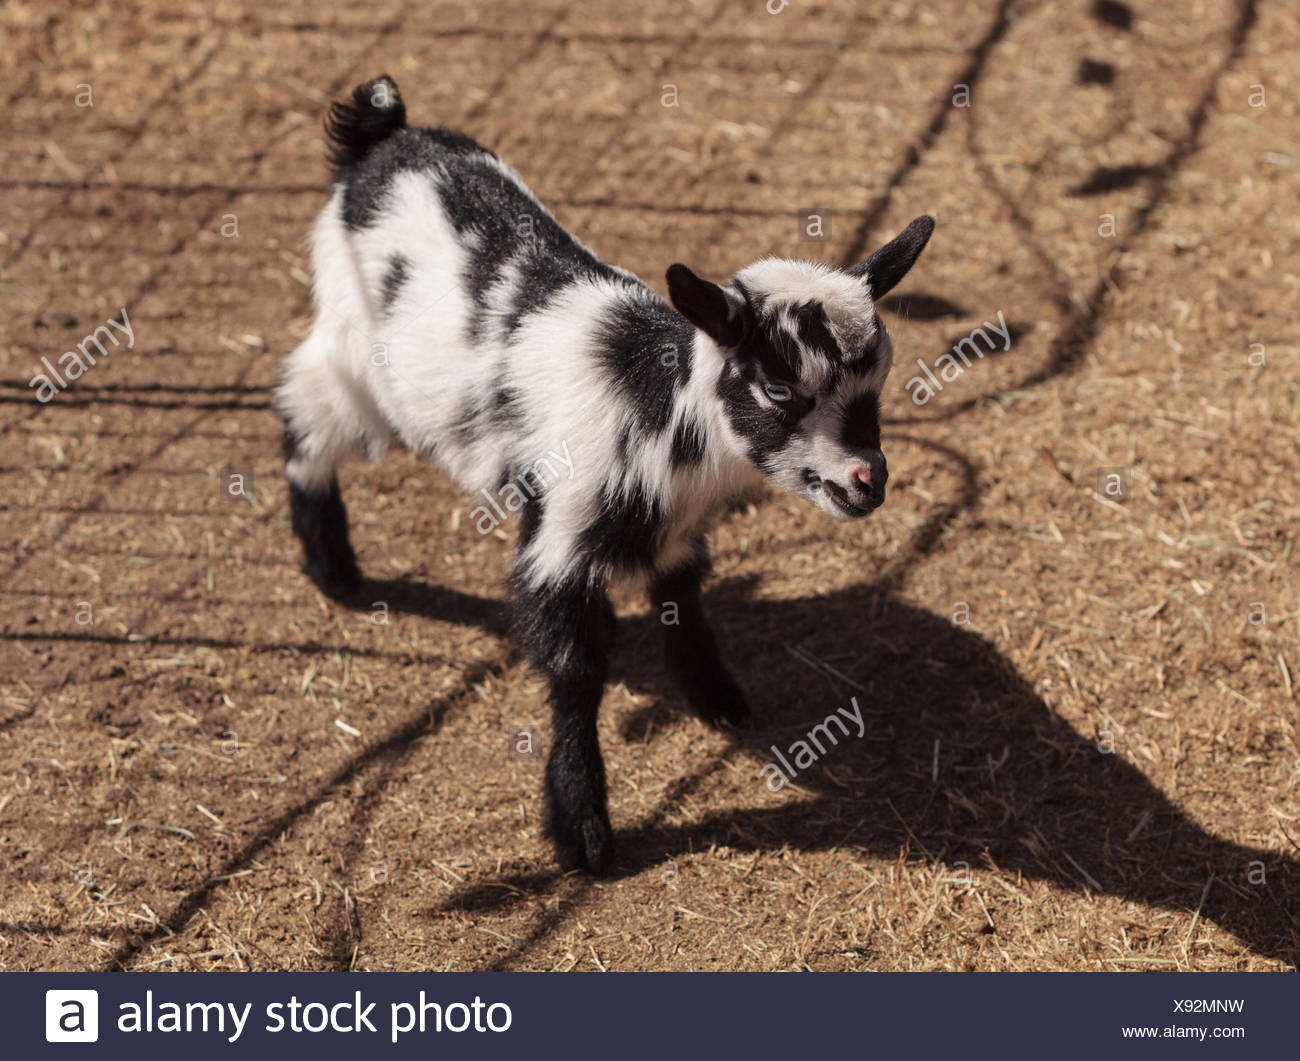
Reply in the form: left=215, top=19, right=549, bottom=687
left=358, top=580, right=1300, bottom=966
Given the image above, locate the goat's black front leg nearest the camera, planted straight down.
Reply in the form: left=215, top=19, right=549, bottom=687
left=515, top=566, right=614, bottom=872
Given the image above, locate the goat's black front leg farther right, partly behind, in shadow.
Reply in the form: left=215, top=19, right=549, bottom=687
left=650, top=551, right=749, bottom=726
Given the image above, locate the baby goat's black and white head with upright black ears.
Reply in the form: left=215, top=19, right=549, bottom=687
left=668, top=217, right=935, bottom=520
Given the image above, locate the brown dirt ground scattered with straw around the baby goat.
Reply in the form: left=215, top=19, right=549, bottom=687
left=0, top=0, right=1300, bottom=970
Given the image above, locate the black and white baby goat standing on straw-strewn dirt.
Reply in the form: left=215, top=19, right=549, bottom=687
left=276, top=77, right=933, bottom=872
